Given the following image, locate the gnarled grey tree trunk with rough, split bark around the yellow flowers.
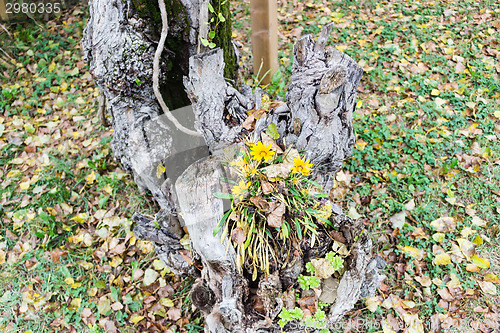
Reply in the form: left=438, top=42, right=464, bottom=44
left=83, top=0, right=383, bottom=326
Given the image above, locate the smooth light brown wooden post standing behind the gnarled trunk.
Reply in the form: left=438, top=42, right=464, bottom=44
left=250, top=0, right=279, bottom=84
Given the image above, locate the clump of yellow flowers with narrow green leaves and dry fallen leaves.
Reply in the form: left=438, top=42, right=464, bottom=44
left=214, top=127, right=333, bottom=279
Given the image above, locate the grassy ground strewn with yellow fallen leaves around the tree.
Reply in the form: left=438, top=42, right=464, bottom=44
left=0, top=0, right=500, bottom=332
